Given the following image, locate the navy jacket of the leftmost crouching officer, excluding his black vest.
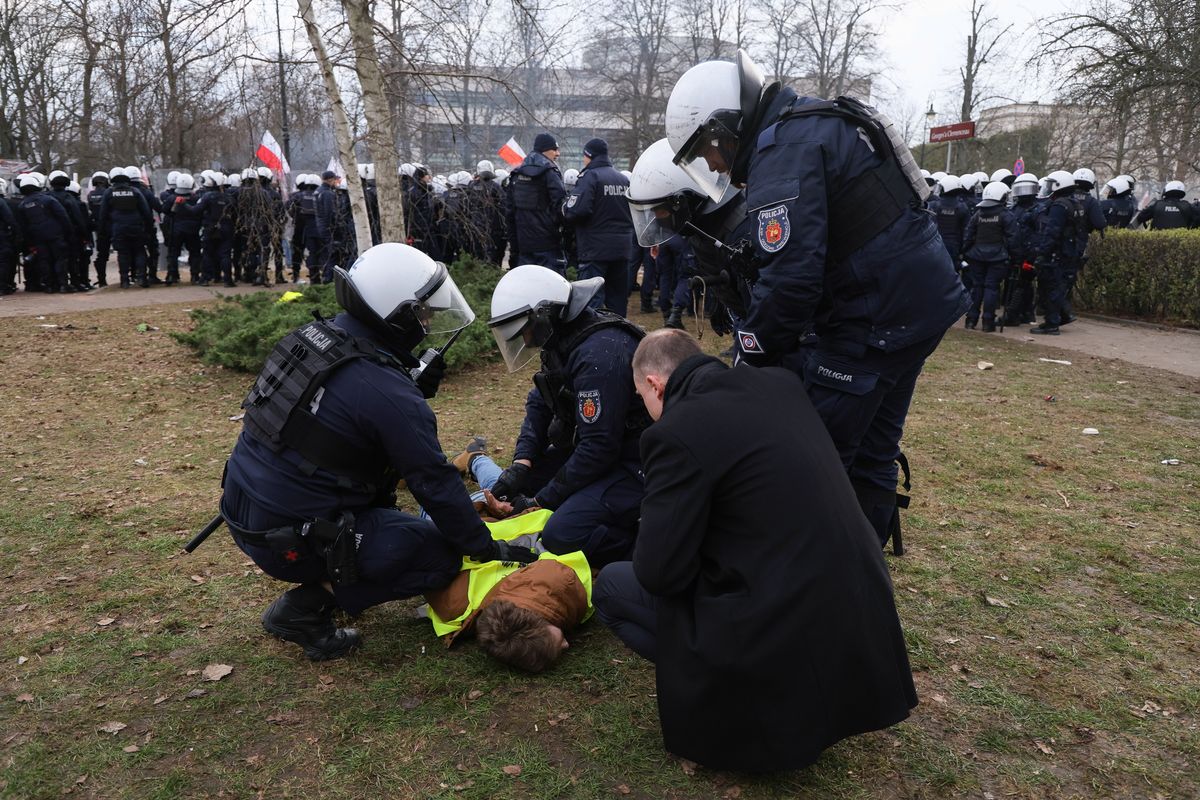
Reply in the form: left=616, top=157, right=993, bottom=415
left=226, top=313, right=491, bottom=554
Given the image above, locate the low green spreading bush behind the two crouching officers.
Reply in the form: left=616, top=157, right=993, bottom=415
left=173, top=258, right=500, bottom=373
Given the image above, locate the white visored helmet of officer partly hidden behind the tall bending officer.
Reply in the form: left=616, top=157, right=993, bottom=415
left=625, top=139, right=738, bottom=247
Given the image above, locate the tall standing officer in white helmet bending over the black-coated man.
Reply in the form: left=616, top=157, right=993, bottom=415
left=666, top=52, right=967, bottom=549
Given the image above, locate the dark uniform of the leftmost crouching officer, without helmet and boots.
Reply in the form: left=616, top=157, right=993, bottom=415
left=221, top=313, right=492, bottom=614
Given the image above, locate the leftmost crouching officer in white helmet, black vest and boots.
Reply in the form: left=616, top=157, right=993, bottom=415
left=221, top=243, right=535, bottom=661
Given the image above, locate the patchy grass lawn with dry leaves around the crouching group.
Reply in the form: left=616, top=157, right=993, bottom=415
left=0, top=306, right=1200, bottom=800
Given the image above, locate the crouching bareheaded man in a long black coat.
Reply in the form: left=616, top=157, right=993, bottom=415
left=593, top=329, right=917, bottom=771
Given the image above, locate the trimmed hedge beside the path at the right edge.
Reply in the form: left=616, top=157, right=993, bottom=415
left=1075, top=230, right=1200, bottom=327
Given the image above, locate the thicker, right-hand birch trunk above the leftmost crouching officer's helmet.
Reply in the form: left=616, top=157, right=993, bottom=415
left=342, top=0, right=404, bottom=242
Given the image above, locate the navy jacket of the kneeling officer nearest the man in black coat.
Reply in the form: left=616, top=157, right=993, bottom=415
left=512, top=311, right=644, bottom=509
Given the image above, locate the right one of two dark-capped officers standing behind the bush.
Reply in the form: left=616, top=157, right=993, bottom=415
left=563, top=139, right=634, bottom=317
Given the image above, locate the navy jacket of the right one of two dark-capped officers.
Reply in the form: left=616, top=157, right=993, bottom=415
left=563, top=156, right=634, bottom=261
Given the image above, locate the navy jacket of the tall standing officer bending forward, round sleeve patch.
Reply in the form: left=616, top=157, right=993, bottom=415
left=737, top=89, right=968, bottom=363
